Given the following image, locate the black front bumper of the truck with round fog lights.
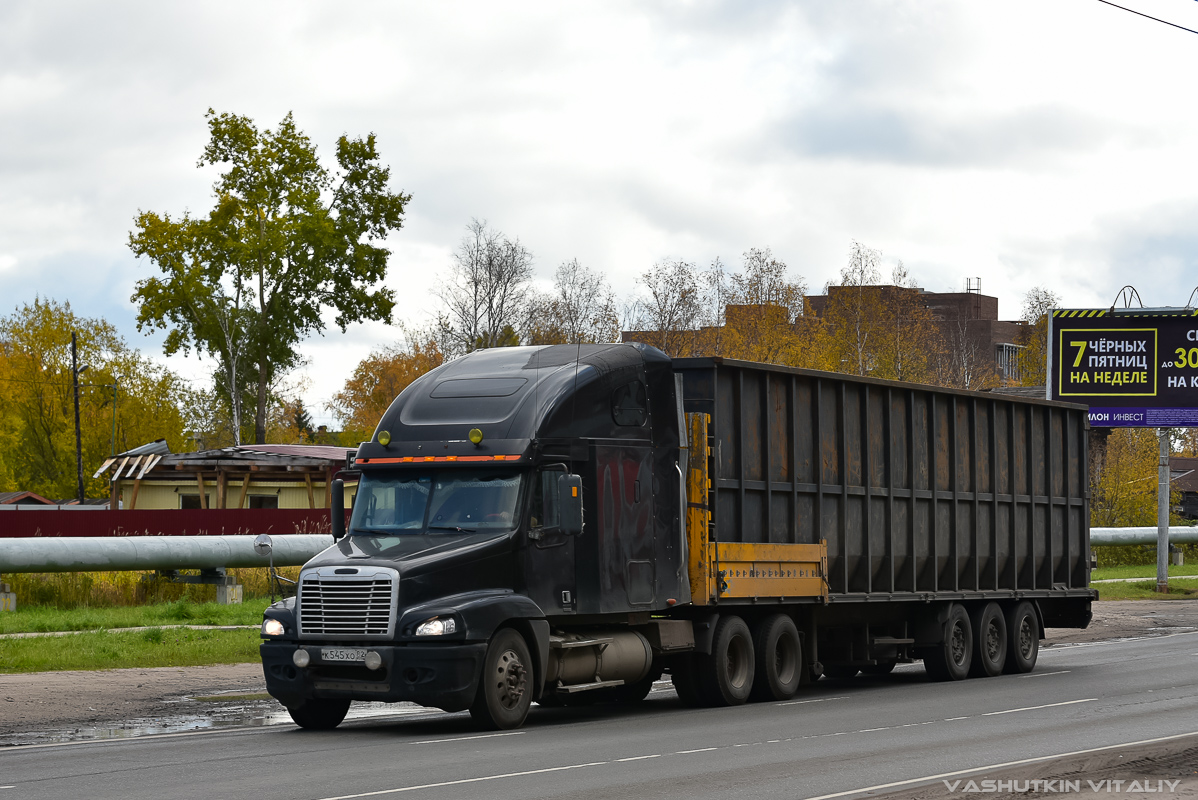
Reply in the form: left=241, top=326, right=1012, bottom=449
left=259, top=642, right=486, bottom=711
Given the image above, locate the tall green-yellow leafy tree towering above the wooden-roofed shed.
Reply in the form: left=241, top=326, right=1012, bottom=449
left=129, top=109, right=411, bottom=443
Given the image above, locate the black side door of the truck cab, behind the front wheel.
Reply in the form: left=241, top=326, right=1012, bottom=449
left=525, top=465, right=577, bottom=616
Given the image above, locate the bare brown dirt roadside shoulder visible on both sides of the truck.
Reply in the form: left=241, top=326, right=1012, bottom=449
left=0, top=600, right=1198, bottom=742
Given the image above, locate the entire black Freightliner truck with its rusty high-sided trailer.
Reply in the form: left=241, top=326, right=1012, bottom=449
left=261, top=344, right=1097, bottom=728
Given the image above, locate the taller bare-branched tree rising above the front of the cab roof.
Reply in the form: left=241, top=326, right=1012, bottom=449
left=437, top=219, right=532, bottom=356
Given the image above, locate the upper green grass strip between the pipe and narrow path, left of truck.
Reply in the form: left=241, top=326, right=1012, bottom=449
left=0, top=599, right=271, bottom=634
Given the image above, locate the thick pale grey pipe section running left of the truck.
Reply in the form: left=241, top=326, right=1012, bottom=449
left=0, top=534, right=333, bottom=574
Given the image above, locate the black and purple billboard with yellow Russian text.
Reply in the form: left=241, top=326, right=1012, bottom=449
left=1047, top=308, right=1198, bottom=428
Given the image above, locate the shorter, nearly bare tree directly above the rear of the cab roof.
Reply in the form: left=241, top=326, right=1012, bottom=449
left=526, top=259, right=619, bottom=345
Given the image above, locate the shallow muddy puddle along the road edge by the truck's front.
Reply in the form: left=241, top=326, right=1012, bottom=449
left=0, top=692, right=444, bottom=747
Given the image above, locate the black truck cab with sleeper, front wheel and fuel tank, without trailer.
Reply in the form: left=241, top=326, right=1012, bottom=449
left=261, top=345, right=689, bottom=727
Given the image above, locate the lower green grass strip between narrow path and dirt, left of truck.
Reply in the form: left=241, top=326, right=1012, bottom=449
left=0, top=628, right=260, bottom=673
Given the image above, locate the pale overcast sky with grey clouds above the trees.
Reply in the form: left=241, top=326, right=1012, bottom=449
left=0, top=0, right=1198, bottom=431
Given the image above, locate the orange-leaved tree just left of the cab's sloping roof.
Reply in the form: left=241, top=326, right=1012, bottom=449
left=328, top=331, right=444, bottom=441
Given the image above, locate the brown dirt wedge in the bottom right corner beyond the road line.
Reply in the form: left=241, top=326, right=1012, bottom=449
left=865, top=737, right=1198, bottom=800
